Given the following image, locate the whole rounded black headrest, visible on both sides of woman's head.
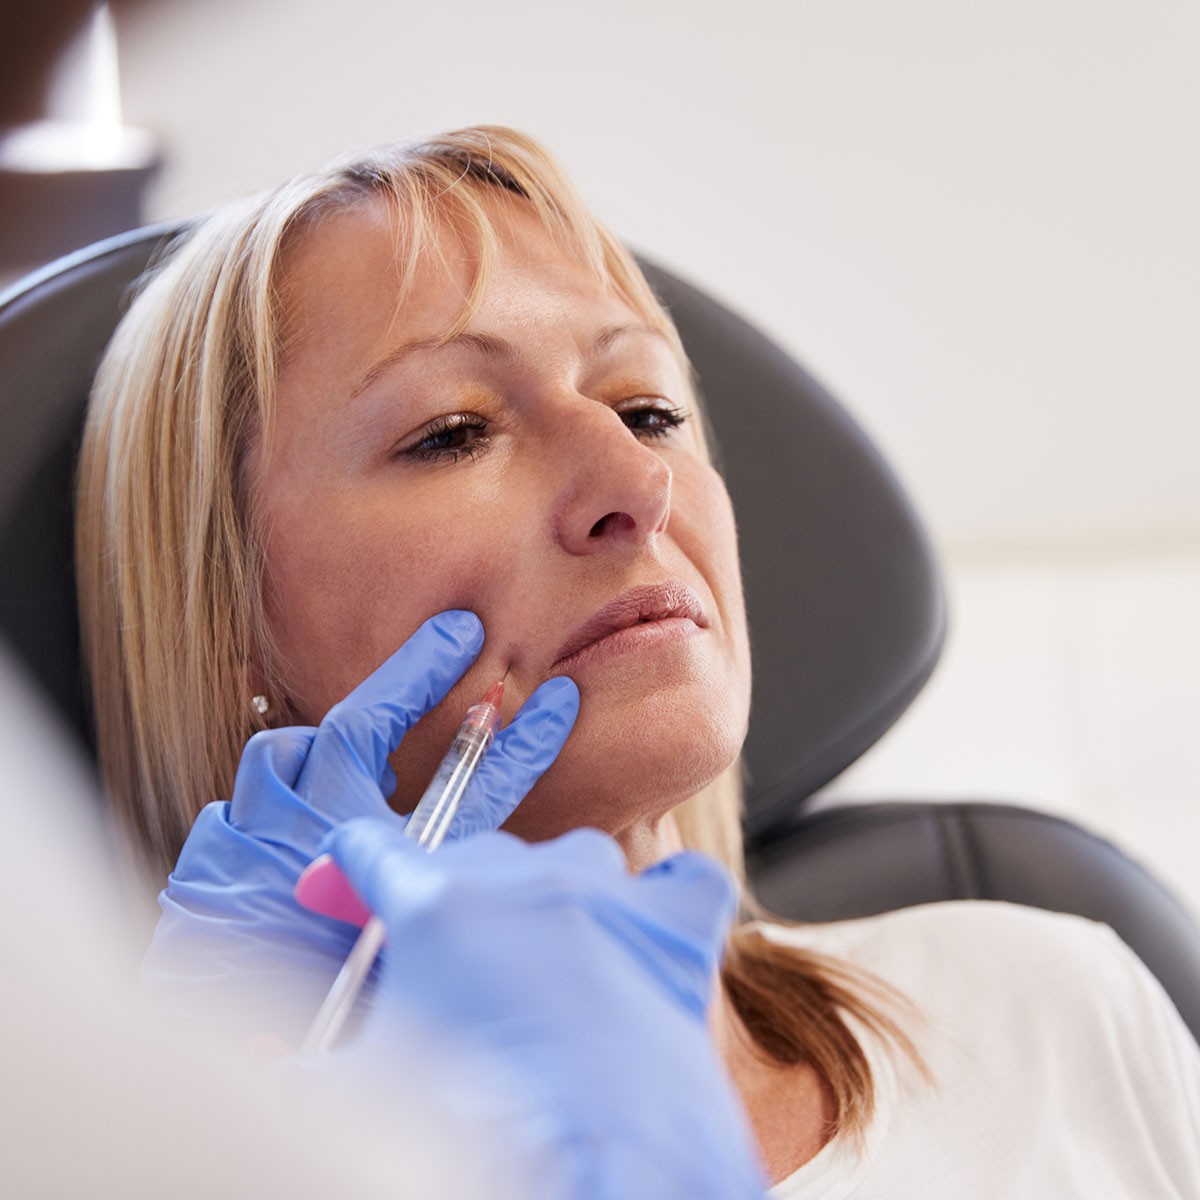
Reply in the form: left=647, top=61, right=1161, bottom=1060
left=0, top=226, right=944, bottom=833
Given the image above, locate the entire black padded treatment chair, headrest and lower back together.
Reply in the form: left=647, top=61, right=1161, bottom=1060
left=7, top=227, right=1200, bottom=1037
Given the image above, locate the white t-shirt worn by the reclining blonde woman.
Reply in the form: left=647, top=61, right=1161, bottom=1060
left=758, top=900, right=1200, bottom=1200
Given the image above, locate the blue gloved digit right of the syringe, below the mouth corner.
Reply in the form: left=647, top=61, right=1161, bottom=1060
left=446, top=676, right=580, bottom=840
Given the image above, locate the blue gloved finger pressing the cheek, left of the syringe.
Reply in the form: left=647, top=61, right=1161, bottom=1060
left=296, top=608, right=484, bottom=821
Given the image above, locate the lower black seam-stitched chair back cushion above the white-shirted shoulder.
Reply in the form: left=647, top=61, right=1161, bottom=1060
left=746, top=802, right=1200, bottom=1039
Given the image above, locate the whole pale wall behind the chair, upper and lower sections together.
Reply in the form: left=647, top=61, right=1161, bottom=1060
left=114, top=0, right=1200, bottom=906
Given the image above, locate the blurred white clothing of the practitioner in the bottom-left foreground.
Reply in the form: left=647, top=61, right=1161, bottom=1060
left=0, top=646, right=496, bottom=1200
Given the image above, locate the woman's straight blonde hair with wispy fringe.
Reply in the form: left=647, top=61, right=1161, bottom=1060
left=77, top=126, right=916, bottom=1133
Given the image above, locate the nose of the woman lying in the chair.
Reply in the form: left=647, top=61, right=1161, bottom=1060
left=556, top=404, right=671, bottom=554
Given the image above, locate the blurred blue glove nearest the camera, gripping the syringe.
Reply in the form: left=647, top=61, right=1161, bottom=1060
left=323, top=818, right=766, bottom=1200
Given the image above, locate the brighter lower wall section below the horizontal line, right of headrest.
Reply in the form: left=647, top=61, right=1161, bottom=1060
left=824, top=552, right=1200, bottom=914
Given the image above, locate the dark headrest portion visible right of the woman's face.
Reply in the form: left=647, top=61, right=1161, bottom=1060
left=643, top=264, right=946, bottom=834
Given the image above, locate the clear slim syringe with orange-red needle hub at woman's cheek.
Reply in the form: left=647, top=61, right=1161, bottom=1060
left=300, top=679, right=504, bottom=1054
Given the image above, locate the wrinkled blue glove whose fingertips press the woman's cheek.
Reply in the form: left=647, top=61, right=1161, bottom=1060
left=142, top=611, right=578, bottom=1044
